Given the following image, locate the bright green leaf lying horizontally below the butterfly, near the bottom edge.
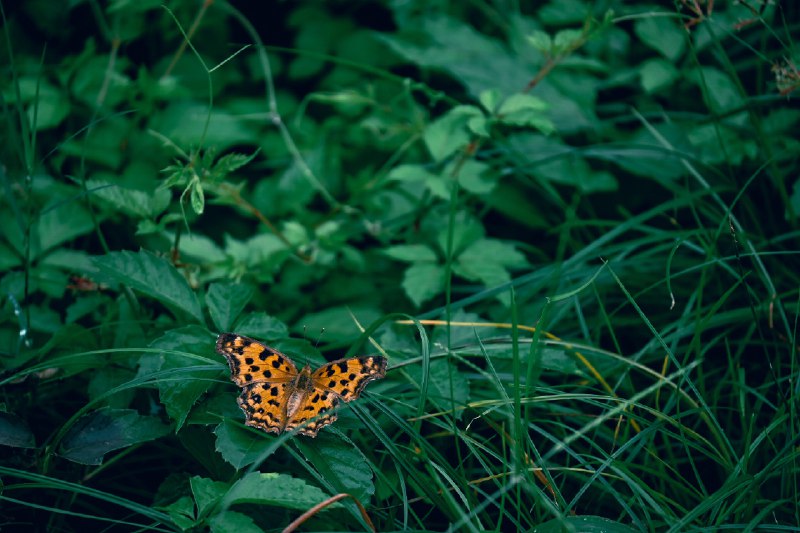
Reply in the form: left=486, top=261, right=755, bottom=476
left=225, top=472, right=328, bottom=511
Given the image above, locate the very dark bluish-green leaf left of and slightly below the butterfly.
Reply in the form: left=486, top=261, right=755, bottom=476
left=59, top=409, right=169, bottom=465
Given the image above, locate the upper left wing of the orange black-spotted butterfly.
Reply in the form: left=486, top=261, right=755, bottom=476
left=217, top=333, right=297, bottom=387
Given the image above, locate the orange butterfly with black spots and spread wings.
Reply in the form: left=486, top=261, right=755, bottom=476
left=217, top=333, right=386, bottom=437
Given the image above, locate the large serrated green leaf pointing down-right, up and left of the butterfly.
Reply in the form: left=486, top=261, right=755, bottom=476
left=92, top=250, right=203, bottom=324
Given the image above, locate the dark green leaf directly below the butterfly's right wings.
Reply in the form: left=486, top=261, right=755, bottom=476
left=296, top=432, right=375, bottom=504
